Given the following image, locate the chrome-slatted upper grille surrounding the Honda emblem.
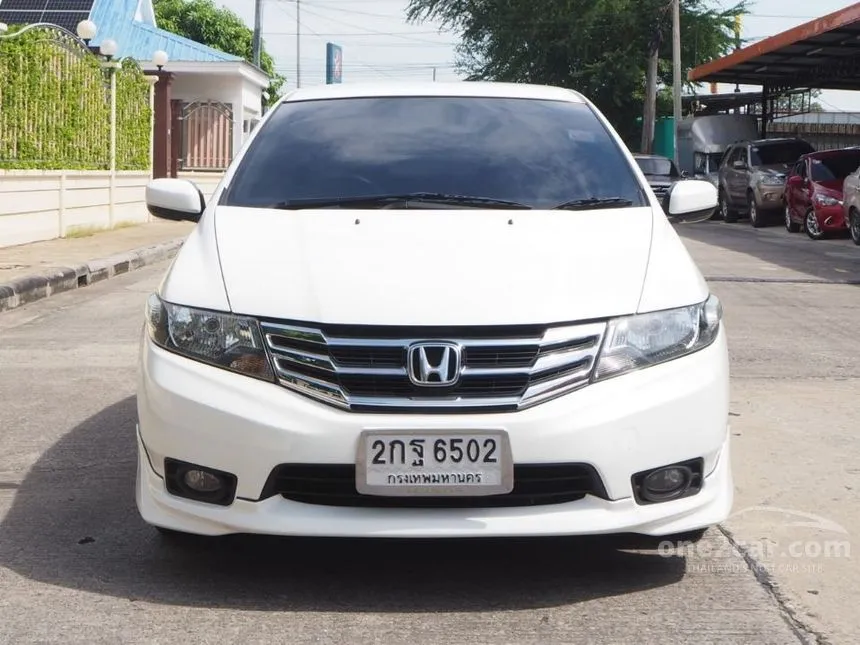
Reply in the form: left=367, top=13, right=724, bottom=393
left=261, top=321, right=606, bottom=412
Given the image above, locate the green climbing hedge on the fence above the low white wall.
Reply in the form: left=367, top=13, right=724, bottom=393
left=0, top=29, right=150, bottom=170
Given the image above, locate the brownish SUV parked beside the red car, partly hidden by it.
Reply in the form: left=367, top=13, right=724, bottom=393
left=719, top=138, right=815, bottom=228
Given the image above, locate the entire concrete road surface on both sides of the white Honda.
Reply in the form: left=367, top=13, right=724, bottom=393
left=0, top=223, right=860, bottom=645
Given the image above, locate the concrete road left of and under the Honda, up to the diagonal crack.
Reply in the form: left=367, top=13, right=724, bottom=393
left=0, top=265, right=813, bottom=645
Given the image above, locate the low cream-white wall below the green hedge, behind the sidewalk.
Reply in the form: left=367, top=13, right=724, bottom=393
left=0, top=170, right=221, bottom=247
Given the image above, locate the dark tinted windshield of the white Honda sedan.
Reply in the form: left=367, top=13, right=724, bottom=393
left=221, top=96, right=648, bottom=208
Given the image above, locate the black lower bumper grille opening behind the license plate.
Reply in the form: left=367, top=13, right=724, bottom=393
left=262, top=464, right=607, bottom=508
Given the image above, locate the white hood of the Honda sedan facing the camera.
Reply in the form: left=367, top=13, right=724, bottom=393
left=214, top=206, right=653, bottom=325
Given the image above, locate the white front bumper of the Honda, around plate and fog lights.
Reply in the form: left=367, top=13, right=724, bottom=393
left=136, top=330, right=733, bottom=537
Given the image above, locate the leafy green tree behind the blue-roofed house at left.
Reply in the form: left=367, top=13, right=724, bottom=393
left=153, top=0, right=285, bottom=105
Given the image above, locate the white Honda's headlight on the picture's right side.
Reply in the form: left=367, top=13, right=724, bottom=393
left=593, top=295, right=723, bottom=381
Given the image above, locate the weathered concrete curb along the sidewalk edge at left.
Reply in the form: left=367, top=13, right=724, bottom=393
left=0, top=237, right=185, bottom=312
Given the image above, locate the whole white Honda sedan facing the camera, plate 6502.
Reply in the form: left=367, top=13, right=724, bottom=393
left=136, top=82, right=733, bottom=538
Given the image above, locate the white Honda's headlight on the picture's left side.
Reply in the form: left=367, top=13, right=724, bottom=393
left=146, top=294, right=274, bottom=381
